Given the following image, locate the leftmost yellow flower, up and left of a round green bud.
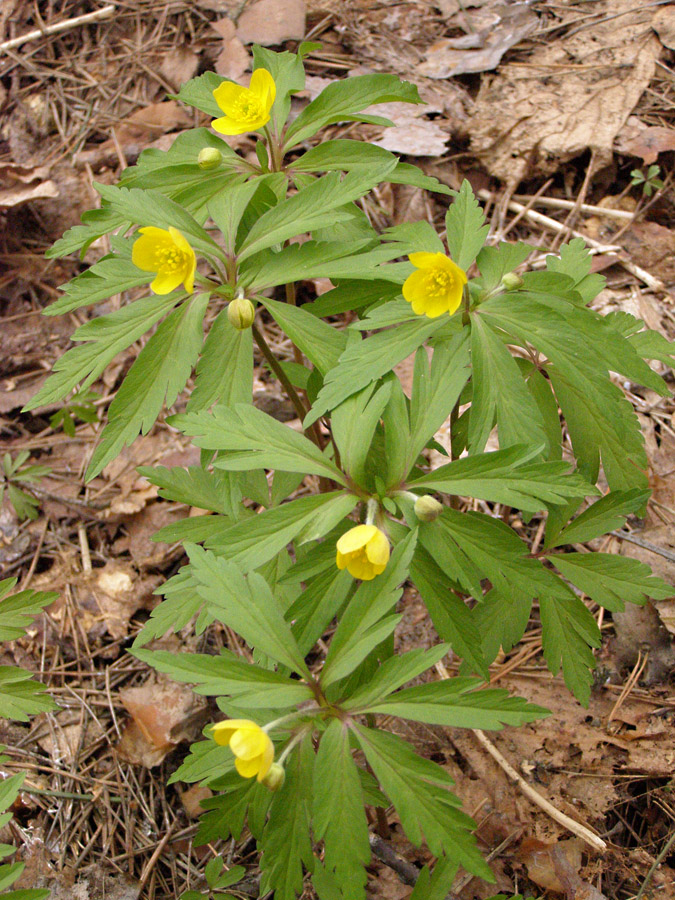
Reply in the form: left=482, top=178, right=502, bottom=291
left=131, top=225, right=197, bottom=294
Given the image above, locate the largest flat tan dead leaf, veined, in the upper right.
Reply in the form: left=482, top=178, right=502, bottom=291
left=467, top=0, right=661, bottom=186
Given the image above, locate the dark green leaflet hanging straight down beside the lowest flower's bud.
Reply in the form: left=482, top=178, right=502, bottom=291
left=260, top=737, right=314, bottom=900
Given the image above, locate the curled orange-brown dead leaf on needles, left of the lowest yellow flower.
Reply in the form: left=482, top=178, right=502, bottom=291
left=117, top=677, right=208, bottom=768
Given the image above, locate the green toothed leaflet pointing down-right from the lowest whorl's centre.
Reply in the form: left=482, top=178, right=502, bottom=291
left=354, top=725, right=493, bottom=881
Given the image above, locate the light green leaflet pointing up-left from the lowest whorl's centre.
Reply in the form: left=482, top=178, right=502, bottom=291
left=185, top=545, right=311, bottom=680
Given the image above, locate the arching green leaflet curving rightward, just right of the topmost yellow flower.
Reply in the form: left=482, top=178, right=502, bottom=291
left=284, top=75, right=422, bottom=151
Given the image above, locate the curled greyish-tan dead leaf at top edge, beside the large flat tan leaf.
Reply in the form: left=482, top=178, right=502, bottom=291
left=417, top=3, right=539, bottom=78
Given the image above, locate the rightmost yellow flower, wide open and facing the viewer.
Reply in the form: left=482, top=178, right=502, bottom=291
left=403, top=253, right=466, bottom=319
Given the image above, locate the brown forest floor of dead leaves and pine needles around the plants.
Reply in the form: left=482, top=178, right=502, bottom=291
left=0, top=0, right=675, bottom=900
